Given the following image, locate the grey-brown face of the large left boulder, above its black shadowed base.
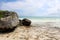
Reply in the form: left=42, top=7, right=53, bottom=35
left=0, top=12, right=19, bottom=29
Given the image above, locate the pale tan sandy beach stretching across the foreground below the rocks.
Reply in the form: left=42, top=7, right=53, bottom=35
left=0, top=22, right=60, bottom=40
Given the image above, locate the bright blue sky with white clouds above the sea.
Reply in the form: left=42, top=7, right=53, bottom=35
left=0, top=0, right=60, bottom=17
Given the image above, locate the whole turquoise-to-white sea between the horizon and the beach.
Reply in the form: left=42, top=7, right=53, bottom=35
left=19, top=16, right=60, bottom=22
